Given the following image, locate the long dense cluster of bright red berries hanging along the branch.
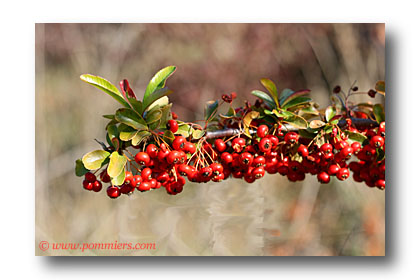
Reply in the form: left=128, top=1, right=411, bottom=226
left=83, top=120, right=385, bottom=198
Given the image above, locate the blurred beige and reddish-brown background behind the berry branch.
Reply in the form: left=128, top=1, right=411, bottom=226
left=35, top=24, right=385, bottom=256
